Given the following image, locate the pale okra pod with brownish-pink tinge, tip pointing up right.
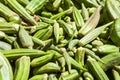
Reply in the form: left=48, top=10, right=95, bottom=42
left=79, top=6, right=101, bottom=35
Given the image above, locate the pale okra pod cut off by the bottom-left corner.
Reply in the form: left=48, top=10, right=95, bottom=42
left=0, top=52, right=13, bottom=80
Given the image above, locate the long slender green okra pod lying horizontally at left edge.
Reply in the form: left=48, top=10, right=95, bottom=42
left=1, top=48, right=46, bottom=60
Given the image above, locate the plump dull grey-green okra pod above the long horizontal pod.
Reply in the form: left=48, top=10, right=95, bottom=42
left=18, top=26, right=34, bottom=49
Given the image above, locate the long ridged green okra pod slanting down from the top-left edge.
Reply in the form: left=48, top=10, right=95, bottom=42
left=6, top=0, right=36, bottom=25
